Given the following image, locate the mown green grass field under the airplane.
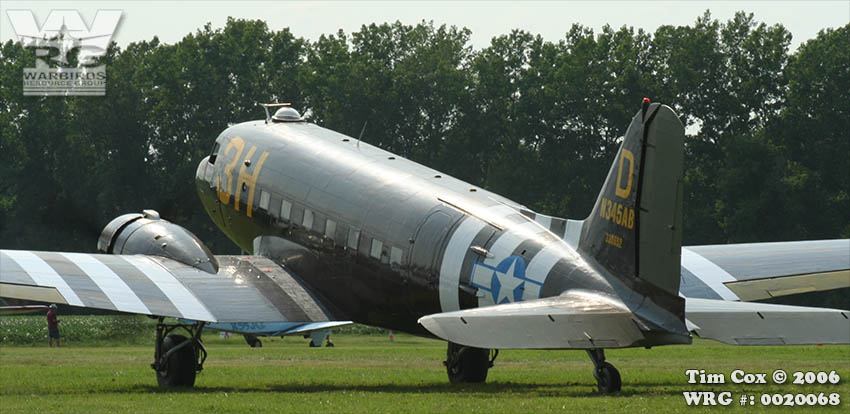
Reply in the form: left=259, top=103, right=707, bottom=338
left=0, top=317, right=850, bottom=414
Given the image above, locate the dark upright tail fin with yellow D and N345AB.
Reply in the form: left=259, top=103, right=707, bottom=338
left=578, top=100, right=685, bottom=297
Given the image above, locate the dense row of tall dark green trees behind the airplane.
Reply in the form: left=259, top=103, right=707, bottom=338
left=0, top=13, right=850, bottom=253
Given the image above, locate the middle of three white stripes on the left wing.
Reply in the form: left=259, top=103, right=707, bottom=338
left=60, top=253, right=151, bottom=315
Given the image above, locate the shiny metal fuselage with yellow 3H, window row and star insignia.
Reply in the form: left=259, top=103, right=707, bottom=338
left=196, top=108, right=689, bottom=344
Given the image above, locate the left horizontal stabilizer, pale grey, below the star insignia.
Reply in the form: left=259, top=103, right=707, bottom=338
left=419, top=292, right=644, bottom=349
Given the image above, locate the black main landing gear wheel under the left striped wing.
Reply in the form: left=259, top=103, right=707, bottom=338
left=151, top=317, right=207, bottom=387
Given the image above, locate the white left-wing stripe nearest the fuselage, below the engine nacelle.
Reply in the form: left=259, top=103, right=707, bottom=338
left=124, top=256, right=217, bottom=322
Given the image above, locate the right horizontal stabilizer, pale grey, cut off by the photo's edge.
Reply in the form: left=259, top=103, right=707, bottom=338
left=685, top=298, right=850, bottom=345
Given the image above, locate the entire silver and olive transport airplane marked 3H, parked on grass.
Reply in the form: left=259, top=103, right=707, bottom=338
left=0, top=100, right=850, bottom=392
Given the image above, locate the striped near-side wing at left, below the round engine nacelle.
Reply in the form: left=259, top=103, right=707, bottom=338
left=0, top=250, right=342, bottom=322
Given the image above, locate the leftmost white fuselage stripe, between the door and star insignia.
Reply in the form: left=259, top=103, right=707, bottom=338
left=440, top=216, right=485, bottom=312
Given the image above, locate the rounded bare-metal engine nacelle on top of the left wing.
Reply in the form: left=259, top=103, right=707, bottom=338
left=97, top=210, right=218, bottom=274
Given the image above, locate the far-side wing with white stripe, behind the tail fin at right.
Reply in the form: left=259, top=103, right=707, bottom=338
left=679, top=239, right=850, bottom=301
